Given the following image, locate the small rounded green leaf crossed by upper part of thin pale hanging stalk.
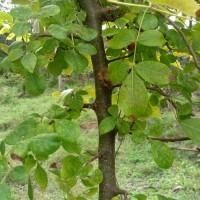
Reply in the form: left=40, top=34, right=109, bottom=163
left=137, top=14, right=158, bottom=30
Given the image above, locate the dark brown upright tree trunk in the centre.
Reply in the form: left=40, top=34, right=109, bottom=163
left=79, top=0, right=119, bottom=200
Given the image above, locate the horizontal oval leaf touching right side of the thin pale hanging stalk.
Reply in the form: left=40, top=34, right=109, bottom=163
left=138, top=30, right=166, bottom=47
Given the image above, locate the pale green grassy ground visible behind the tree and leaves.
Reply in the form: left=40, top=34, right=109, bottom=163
left=0, top=76, right=200, bottom=200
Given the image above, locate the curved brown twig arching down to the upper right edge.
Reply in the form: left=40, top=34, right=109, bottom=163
left=161, top=13, right=200, bottom=71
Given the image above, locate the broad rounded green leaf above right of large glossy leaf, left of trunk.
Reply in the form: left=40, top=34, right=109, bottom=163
left=55, top=119, right=81, bottom=143
